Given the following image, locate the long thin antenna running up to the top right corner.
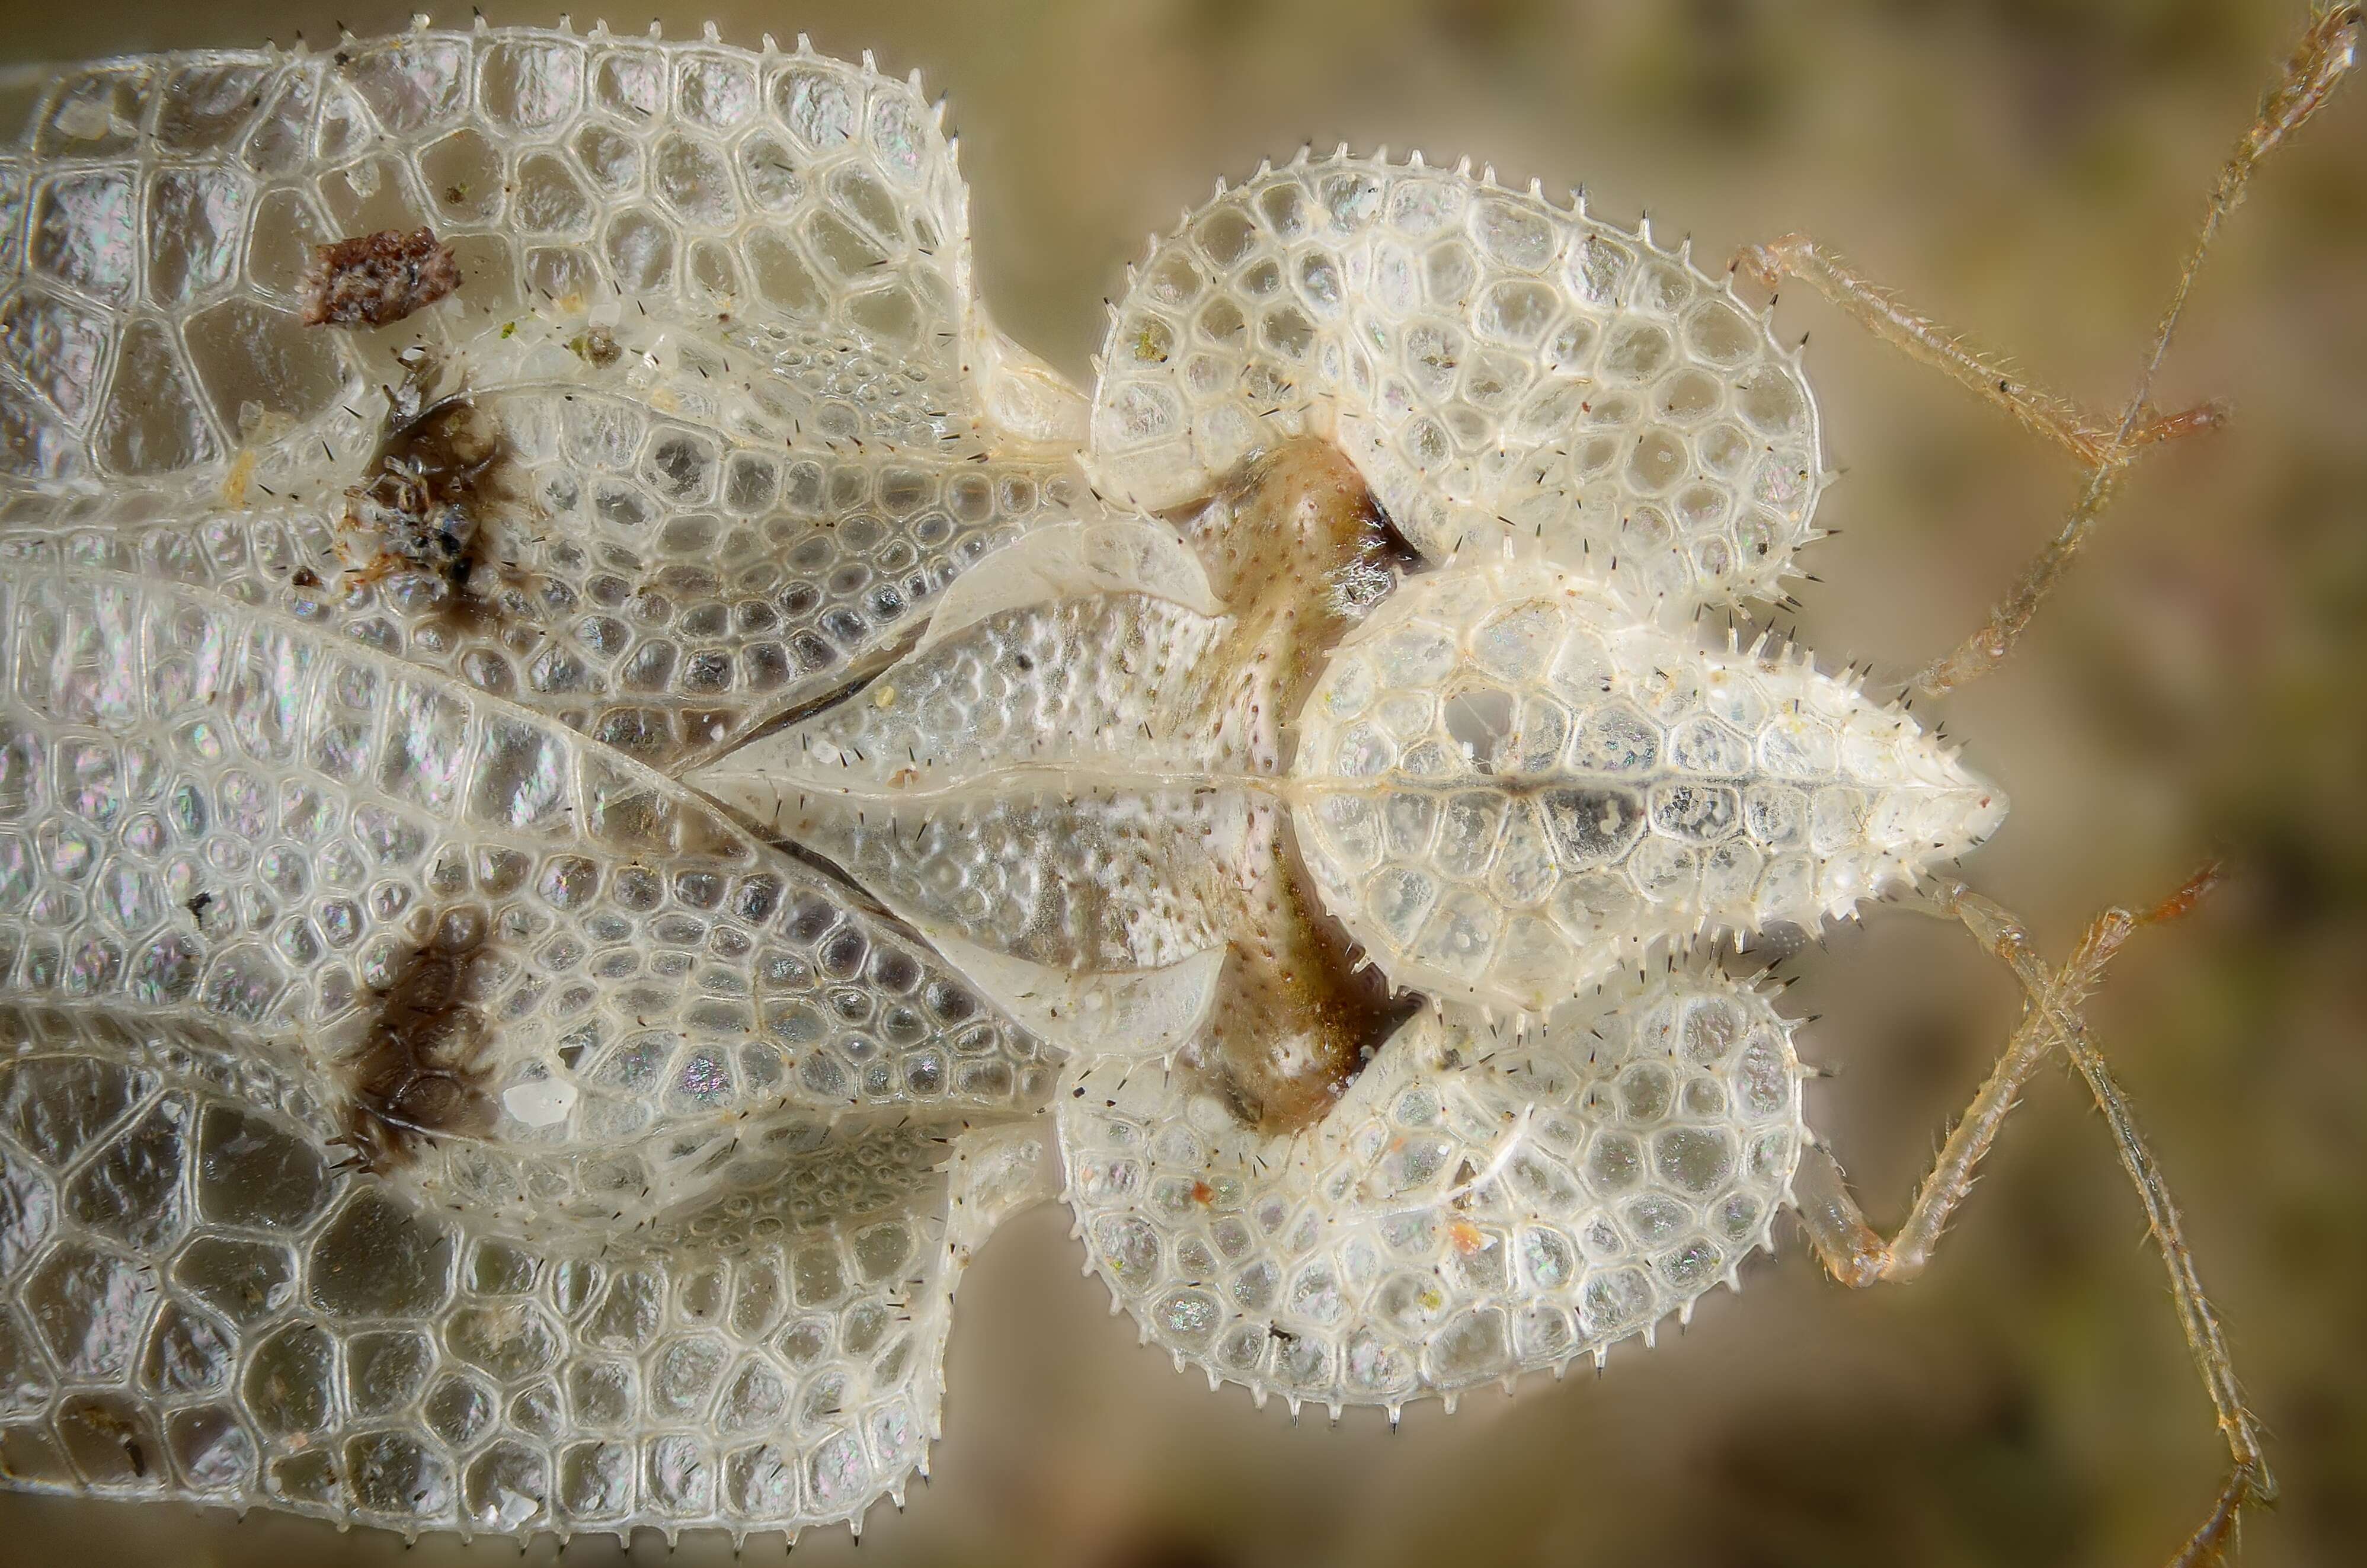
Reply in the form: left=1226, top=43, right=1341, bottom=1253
left=1915, top=5, right=2362, bottom=696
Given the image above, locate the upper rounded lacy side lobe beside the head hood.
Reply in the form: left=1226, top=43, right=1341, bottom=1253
left=1091, top=149, right=1822, bottom=616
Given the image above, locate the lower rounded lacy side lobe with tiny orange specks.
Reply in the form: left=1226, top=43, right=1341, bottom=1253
left=1055, top=971, right=1806, bottom=1409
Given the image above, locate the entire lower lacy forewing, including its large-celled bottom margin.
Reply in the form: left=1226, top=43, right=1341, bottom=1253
left=0, top=559, right=1051, bottom=1530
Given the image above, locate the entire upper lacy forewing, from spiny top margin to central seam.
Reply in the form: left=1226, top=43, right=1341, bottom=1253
left=0, top=28, right=1084, bottom=767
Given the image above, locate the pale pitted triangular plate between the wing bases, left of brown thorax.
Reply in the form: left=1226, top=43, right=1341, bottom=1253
left=691, top=521, right=1271, bottom=974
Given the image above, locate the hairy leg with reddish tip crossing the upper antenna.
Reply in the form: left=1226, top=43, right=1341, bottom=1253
left=1735, top=235, right=2227, bottom=469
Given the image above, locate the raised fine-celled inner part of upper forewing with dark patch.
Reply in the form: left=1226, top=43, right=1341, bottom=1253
left=0, top=389, right=1082, bottom=770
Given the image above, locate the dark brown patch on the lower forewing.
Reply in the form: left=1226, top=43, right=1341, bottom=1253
left=334, top=910, right=492, bottom=1173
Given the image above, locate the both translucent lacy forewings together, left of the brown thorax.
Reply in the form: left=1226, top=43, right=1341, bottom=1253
left=0, top=28, right=1084, bottom=1532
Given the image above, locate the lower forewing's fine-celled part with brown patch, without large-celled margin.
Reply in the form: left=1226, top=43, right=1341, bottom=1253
left=0, top=571, right=1053, bottom=1236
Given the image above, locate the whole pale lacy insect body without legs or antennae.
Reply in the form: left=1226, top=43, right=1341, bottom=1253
left=0, top=12, right=2035, bottom=1563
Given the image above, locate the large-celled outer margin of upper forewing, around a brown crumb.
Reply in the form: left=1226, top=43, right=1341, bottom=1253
left=0, top=28, right=1074, bottom=504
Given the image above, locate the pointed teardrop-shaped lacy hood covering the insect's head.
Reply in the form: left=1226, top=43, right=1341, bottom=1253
left=1293, top=561, right=2005, bottom=1014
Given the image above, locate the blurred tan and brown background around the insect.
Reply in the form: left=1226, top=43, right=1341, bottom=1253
left=0, top=0, right=2367, bottom=1568
